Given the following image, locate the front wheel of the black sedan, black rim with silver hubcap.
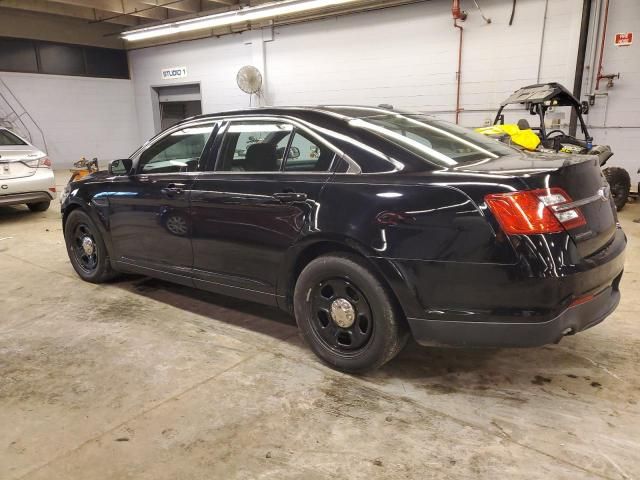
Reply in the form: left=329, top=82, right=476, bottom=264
left=64, top=210, right=117, bottom=283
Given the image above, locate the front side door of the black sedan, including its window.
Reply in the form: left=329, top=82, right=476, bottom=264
left=108, top=121, right=218, bottom=285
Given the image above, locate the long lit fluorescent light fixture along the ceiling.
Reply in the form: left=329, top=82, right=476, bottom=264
left=122, top=0, right=357, bottom=41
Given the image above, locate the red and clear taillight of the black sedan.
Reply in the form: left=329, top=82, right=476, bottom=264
left=485, top=188, right=586, bottom=235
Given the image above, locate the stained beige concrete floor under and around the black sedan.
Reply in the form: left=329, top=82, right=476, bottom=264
left=0, top=173, right=640, bottom=480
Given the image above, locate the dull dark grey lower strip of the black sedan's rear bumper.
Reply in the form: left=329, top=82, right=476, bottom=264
left=408, top=278, right=620, bottom=347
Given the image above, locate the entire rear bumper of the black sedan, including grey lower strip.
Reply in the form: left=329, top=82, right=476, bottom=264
left=383, top=229, right=626, bottom=347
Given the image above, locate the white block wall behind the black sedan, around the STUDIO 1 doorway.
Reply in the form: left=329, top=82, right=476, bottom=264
left=130, top=0, right=640, bottom=187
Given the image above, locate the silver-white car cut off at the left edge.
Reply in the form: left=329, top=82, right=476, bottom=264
left=0, top=128, right=56, bottom=212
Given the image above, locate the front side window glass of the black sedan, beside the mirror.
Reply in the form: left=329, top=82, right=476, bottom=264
left=138, top=123, right=215, bottom=174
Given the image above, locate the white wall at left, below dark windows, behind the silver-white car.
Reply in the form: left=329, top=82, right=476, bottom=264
left=0, top=72, right=140, bottom=169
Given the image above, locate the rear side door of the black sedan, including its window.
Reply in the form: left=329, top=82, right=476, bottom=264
left=191, top=118, right=336, bottom=303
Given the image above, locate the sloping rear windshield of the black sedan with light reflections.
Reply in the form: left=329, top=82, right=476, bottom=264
left=349, top=114, right=514, bottom=167
